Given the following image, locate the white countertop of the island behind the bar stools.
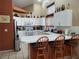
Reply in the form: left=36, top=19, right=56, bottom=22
left=20, top=32, right=71, bottom=43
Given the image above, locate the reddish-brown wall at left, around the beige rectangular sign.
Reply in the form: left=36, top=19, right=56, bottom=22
left=0, top=0, right=14, bottom=50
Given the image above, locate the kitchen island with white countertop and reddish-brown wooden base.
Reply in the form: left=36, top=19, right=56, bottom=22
left=20, top=32, right=78, bottom=59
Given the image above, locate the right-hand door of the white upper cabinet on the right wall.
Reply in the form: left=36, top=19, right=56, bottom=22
left=60, top=10, right=72, bottom=26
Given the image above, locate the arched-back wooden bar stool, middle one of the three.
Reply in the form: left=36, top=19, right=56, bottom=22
left=54, top=35, right=65, bottom=59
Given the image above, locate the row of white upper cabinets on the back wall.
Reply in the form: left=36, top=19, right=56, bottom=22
left=14, top=17, right=45, bottom=26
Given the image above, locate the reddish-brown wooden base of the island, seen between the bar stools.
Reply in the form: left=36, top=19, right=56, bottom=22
left=29, top=42, right=71, bottom=59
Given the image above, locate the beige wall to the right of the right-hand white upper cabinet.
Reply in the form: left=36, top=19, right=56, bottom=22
left=68, top=0, right=79, bottom=26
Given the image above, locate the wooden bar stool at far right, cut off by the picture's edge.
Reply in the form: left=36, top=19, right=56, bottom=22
left=70, top=34, right=79, bottom=58
